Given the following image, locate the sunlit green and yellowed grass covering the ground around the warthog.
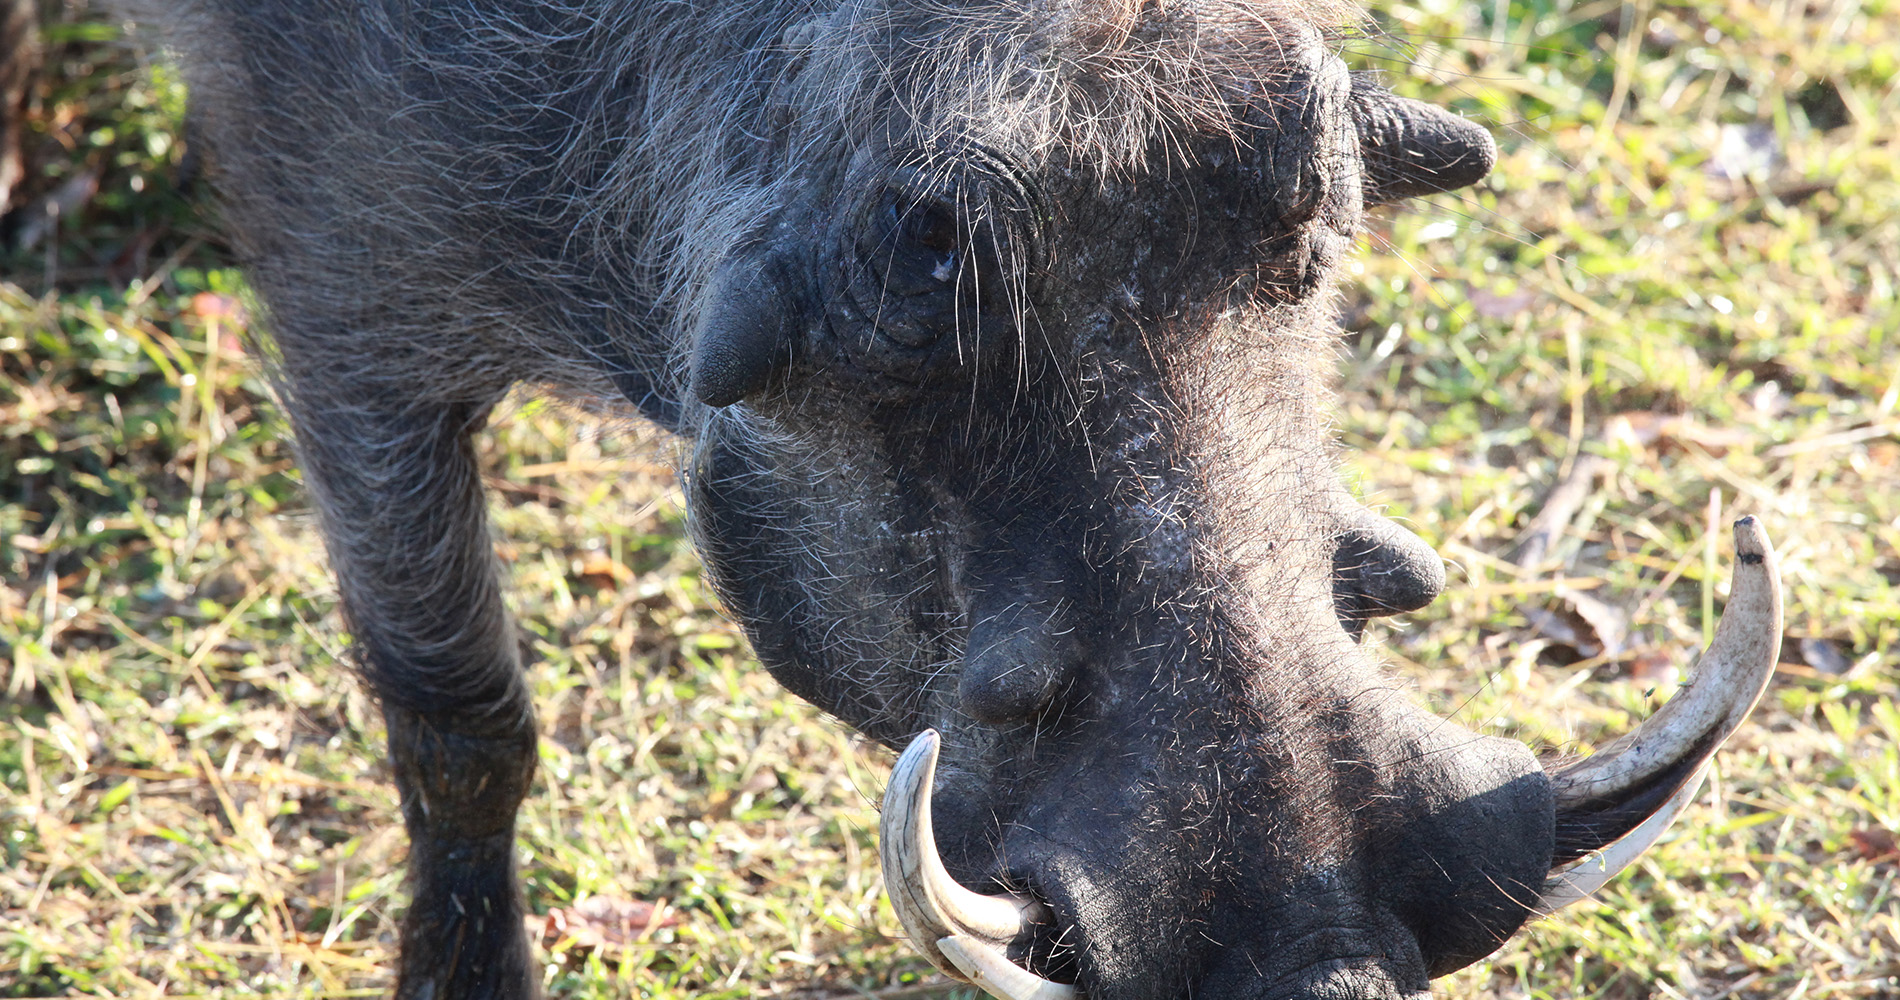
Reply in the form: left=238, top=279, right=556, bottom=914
left=0, top=0, right=1900, bottom=1000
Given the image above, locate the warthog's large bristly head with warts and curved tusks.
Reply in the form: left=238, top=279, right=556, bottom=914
left=672, top=0, right=1778, bottom=1000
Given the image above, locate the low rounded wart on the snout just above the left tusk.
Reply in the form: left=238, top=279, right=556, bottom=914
left=958, top=603, right=1081, bottom=724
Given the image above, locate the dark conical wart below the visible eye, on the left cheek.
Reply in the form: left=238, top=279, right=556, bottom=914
left=690, top=257, right=794, bottom=407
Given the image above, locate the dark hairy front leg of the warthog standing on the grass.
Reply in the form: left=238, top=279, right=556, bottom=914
left=287, top=399, right=538, bottom=1000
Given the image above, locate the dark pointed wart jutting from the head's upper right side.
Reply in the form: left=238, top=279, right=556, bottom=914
left=1353, top=76, right=1497, bottom=205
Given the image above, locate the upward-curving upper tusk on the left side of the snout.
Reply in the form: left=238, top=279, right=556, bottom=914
left=878, top=730, right=1049, bottom=979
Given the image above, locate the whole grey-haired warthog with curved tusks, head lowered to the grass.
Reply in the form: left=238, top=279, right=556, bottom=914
left=130, top=0, right=1780, bottom=1000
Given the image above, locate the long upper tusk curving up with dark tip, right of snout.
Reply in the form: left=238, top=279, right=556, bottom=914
left=1550, top=517, right=1782, bottom=809
